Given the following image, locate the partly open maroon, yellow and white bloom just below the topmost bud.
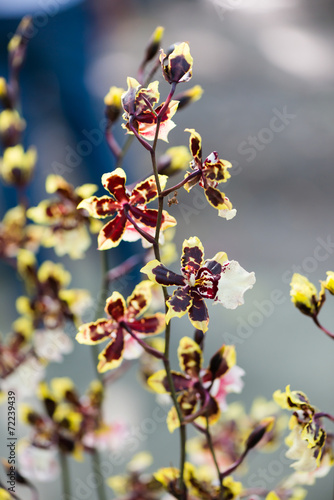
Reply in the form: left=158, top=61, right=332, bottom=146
left=122, top=77, right=179, bottom=142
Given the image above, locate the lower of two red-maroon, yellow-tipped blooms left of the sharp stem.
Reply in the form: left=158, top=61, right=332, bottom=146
left=76, top=281, right=165, bottom=373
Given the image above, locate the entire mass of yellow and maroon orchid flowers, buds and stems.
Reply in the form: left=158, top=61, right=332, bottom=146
left=0, top=18, right=334, bottom=500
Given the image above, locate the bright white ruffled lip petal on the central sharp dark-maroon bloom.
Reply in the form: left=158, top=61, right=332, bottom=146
left=215, top=260, right=256, bottom=309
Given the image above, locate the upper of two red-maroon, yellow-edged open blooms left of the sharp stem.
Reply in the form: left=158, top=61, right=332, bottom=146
left=78, top=168, right=176, bottom=250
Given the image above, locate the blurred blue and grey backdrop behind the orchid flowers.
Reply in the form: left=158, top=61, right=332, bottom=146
left=0, top=0, right=334, bottom=500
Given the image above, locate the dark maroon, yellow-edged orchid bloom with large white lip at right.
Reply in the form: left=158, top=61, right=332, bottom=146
left=141, top=236, right=255, bottom=332
